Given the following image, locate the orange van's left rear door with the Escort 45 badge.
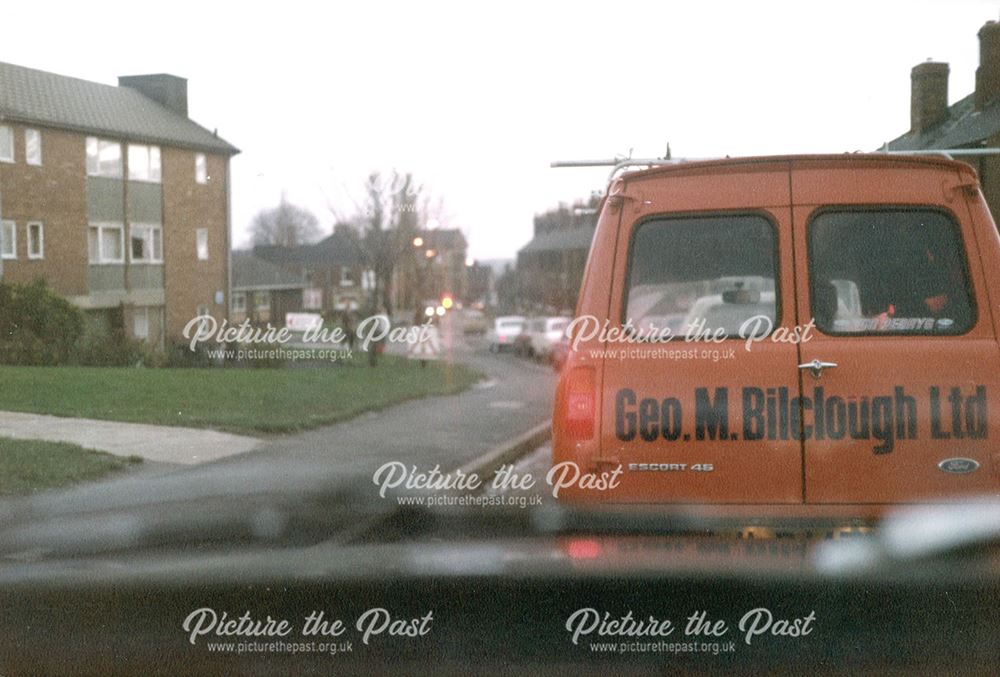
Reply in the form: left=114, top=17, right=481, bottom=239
left=600, top=162, right=802, bottom=503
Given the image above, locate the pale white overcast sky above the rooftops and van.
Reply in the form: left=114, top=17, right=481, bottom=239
left=0, top=0, right=1000, bottom=258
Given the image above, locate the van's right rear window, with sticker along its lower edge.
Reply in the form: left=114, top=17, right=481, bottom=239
left=808, top=209, right=975, bottom=335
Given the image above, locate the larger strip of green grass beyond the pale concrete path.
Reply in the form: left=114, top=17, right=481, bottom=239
left=0, top=356, right=480, bottom=434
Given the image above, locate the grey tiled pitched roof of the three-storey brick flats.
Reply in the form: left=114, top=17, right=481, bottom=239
left=0, top=62, right=239, bottom=155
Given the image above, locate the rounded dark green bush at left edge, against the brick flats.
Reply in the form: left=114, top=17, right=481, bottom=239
left=0, top=280, right=84, bottom=365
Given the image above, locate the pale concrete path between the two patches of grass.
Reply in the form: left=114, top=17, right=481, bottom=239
left=0, top=411, right=261, bottom=465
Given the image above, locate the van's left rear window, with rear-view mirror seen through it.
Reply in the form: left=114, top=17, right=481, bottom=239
left=623, top=214, right=778, bottom=336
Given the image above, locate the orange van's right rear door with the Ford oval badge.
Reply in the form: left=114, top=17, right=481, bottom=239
left=792, top=160, right=1000, bottom=503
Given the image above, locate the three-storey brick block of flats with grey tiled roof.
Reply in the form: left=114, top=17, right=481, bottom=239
left=0, top=63, right=239, bottom=345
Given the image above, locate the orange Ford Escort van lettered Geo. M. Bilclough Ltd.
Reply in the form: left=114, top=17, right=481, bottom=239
left=552, top=154, right=1000, bottom=516
